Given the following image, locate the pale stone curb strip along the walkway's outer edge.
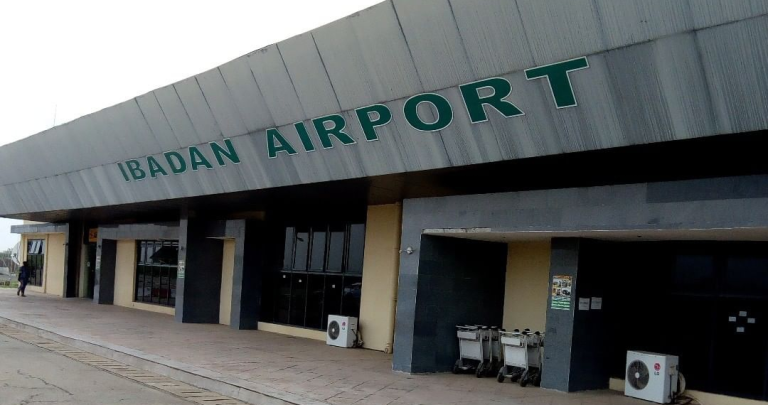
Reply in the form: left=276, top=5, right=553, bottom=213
left=0, top=316, right=328, bottom=405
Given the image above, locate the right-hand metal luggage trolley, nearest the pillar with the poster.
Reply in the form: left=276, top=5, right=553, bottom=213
left=496, top=329, right=544, bottom=387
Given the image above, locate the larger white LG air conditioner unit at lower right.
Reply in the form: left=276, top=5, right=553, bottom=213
left=624, top=351, right=678, bottom=404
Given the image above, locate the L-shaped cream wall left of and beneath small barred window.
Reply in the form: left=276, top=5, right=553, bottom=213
left=113, top=240, right=176, bottom=315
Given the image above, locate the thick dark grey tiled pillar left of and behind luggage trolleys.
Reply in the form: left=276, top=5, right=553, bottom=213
left=393, top=235, right=507, bottom=373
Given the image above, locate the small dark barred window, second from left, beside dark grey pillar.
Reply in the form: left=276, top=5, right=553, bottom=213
left=134, top=240, right=179, bottom=307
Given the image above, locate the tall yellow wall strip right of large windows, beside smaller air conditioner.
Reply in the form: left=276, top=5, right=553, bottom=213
left=360, top=204, right=402, bottom=352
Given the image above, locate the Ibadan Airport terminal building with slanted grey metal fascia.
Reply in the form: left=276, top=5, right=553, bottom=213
left=6, top=0, right=768, bottom=401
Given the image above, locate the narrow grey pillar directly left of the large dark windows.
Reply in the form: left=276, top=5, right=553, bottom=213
left=227, top=220, right=265, bottom=329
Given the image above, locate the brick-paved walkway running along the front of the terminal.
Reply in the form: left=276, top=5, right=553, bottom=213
left=0, top=289, right=644, bottom=405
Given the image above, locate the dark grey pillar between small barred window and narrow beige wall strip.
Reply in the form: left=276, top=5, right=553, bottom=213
left=176, top=218, right=223, bottom=323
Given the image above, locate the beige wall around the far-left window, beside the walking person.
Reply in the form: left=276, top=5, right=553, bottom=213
left=21, top=233, right=66, bottom=297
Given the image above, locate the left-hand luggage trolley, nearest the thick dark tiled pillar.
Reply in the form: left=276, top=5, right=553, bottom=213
left=452, top=325, right=491, bottom=378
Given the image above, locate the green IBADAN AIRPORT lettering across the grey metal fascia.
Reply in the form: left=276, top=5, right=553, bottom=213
left=115, top=57, right=589, bottom=175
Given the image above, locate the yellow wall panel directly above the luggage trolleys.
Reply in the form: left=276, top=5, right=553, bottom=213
left=503, top=241, right=551, bottom=331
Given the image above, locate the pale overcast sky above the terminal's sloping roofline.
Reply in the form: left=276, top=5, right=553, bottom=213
left=0, top=0, right=382, bottom=250
